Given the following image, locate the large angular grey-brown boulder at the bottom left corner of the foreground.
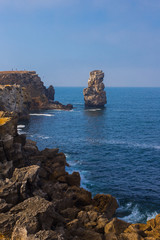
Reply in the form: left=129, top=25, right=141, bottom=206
left=0, top=197, right=64, bottom=239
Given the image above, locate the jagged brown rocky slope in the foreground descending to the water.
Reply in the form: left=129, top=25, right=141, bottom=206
left=0, top=112, right=160, bottom=240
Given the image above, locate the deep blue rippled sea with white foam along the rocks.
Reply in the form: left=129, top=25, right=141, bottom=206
left=18, top=87, right=160, bottom=223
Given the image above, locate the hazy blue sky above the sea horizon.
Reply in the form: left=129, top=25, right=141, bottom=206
left=0, top=0, right=160, bottom=87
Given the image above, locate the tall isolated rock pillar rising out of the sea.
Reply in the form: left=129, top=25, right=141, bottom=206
left=83, top=70, right=107, bottom=107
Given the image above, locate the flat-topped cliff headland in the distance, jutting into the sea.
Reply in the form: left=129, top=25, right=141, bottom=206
left=0, top=71, right=73, bottom=116
